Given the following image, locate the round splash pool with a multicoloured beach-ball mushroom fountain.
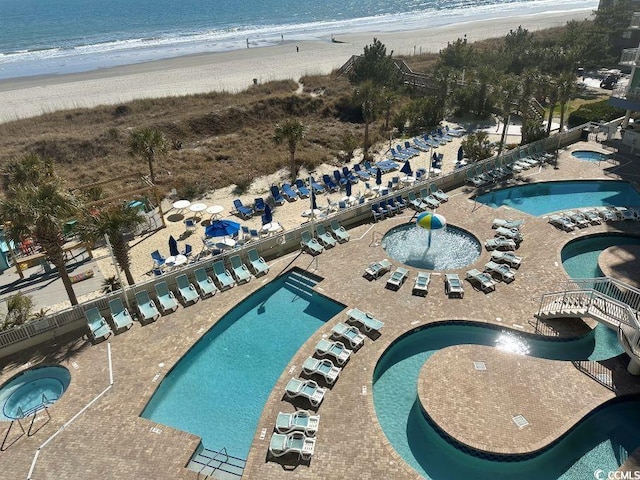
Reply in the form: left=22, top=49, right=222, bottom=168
left=382, top=223, right=482, bottom=270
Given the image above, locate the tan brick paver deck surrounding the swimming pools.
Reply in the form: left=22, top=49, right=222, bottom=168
left=0, top=142, right=640, bottom=480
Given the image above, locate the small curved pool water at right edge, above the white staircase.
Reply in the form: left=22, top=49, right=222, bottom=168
left=560, top=234, right=640, bottom=278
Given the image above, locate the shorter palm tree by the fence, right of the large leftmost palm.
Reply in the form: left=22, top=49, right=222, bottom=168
left=78, top=204, right=145, bottom=285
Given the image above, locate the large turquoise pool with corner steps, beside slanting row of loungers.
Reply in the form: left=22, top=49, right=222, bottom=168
left=142, top=272, right=344, bottom=458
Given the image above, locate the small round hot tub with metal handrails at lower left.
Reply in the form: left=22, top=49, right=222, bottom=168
left=0, top=365, right=71, bottom=420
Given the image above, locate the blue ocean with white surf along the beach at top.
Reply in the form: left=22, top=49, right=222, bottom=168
left=0, top=0, right=598, bottom=79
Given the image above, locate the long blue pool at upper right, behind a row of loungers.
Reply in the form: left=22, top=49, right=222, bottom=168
left=476, top=180, right=640, bottom=216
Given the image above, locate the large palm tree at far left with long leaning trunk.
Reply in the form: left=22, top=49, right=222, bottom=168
left=0, top=175, right=80, bottom=305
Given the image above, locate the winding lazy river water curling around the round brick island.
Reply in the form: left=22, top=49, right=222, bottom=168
left=373, top=322, right=628, bottom=480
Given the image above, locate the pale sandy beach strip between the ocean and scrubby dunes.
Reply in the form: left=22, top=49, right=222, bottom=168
left=0, top=8, right=592, bottom=122
